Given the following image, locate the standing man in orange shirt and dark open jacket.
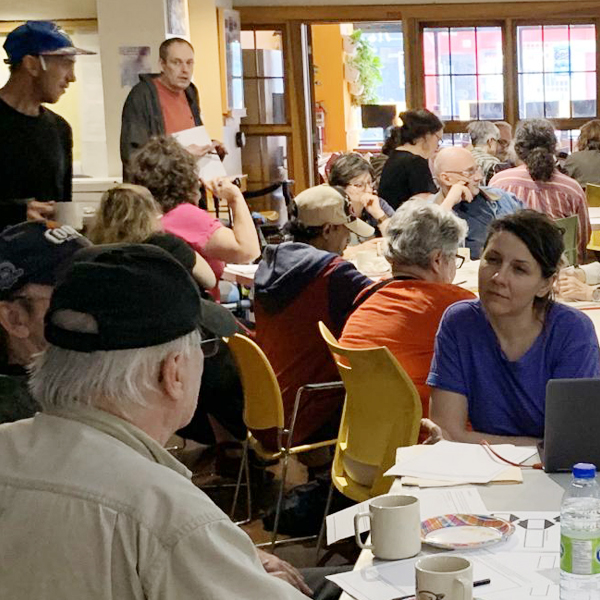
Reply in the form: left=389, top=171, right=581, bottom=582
left=121, top=38, right=227, bottom=180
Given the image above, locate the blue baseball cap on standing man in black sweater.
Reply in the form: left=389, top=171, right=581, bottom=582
left=4, top=21, right=96, bottom=65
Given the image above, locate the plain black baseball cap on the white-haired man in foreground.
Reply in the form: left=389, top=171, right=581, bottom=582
left=45, top=244, right=237, bottom=352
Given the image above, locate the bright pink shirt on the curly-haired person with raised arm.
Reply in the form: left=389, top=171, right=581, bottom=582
left=162, top=202, right=225, bottom=281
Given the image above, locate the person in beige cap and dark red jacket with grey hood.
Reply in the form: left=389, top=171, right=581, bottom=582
left=254, top=185, right=375, bottom=447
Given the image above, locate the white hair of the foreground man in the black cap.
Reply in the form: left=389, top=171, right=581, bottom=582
left=29, top=331, right=202, bottom=415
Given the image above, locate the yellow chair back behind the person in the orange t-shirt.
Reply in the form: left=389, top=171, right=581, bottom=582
left=319, top=322, right=422, bottom=501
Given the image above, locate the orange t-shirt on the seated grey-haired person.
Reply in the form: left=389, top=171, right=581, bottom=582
left=340, top=279, right=475, bottom=417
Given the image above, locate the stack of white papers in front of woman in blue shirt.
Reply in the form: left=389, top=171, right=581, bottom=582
left=386, top=440, right=536, bottom=483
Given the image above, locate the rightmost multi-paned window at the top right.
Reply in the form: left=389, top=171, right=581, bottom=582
left=517, top=25, right=596, bottom=119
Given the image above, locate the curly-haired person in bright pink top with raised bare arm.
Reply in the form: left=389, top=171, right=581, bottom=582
left=131, top=137, right=260, bottom=296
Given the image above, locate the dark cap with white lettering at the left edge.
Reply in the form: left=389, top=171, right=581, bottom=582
left=0, top=221, right=91, bottom=300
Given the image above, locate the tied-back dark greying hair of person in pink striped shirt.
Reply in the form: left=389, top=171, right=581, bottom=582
left=515, top=119, right=557, bottom=182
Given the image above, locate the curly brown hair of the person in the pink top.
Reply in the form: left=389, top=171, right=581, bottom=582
left=130, top=136, right=199, bottom=213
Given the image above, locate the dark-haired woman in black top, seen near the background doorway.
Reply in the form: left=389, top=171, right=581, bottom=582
left=378, top=108, right=444, bottom=209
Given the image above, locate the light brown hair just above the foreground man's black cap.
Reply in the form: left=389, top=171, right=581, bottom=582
left=88, top=183, right=162, bottom=244
